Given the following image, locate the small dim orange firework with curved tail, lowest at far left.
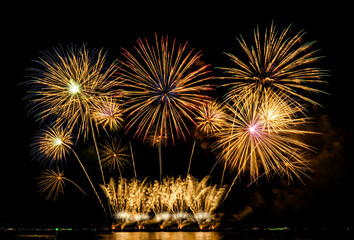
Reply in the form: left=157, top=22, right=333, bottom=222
left=36, top=169, right=86, bottom=201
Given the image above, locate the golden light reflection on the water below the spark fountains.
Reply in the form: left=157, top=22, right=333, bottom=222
left=100, top=232, right=223, bottom=240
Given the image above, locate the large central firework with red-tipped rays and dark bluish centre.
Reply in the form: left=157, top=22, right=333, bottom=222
left=119, top=36, right=211, bottom=143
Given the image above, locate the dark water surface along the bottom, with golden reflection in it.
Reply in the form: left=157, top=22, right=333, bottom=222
left=0, top=231, right=354, bottom=240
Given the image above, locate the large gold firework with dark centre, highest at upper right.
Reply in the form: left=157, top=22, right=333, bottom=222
left=221, top=24, right=327, bottom=104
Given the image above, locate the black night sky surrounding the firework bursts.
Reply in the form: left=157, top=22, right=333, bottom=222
left=0, top=1, right=354, bottom=231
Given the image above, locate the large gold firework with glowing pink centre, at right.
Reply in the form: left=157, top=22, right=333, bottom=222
left=214, top=93, right=312, bottom=180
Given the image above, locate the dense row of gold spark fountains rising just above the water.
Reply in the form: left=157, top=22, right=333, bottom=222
left=101, top=175, right=226, bottom=229
